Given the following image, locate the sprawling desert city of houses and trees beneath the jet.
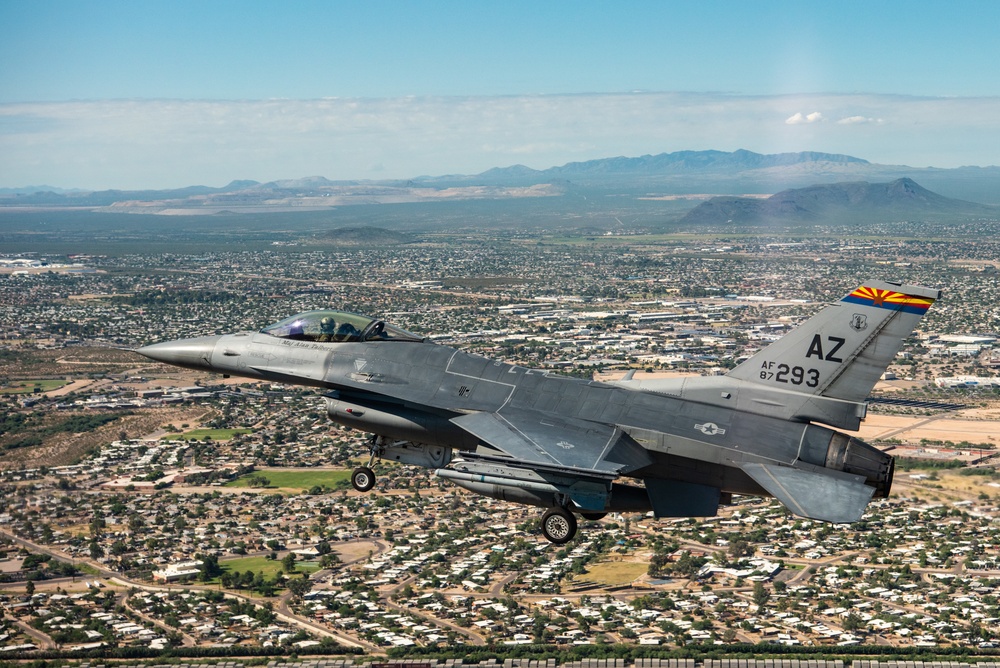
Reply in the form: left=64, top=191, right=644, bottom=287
left=0, top=228, right=1000, bottom=657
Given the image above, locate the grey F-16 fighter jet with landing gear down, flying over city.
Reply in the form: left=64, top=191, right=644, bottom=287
left=137, top=281, right=941, bottom=544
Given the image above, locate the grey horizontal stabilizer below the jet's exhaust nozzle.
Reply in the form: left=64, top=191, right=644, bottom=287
left=742, top=463, right=875, bottom=523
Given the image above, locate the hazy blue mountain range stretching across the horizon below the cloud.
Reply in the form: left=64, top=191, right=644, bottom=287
left=0, top=150, right=1000, bottom=215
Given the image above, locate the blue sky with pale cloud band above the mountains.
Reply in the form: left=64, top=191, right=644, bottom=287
left=0, top=0, right=1000, bottom=190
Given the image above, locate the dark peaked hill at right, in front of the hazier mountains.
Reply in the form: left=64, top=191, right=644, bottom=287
left=680, top=178, right=1000, bottom=226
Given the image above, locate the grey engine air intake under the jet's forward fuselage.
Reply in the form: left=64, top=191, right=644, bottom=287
left=326, top=397, right=478, bottom=449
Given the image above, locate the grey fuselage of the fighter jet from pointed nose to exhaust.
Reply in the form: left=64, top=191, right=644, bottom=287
left=143, top=332, right=891, bottom=514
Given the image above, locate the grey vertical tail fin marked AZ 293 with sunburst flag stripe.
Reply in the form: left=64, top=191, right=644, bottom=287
left=728, top=281, right=941, bottom=402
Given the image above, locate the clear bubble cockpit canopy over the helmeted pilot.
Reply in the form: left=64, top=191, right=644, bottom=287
left=260, top=311, right=424, bottom=343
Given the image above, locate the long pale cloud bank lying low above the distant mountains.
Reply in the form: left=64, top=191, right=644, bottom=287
left=0, top=93, right=1000, bottom=189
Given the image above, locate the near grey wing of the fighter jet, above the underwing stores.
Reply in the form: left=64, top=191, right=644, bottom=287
left=451, top=409, right=652, bottom=476
